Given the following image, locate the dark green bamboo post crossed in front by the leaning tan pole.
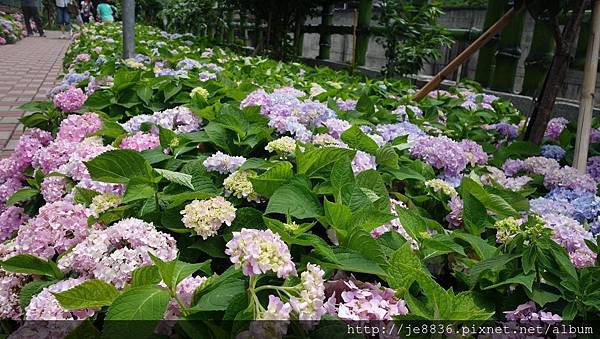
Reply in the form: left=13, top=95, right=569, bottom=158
left=475, top=0, right=507, bottom=87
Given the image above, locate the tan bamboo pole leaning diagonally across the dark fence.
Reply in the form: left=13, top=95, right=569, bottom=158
left=414, top=6, right=524, bottom=101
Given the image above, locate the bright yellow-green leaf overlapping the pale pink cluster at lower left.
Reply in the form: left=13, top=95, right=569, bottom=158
left=53, top=279, right=119, bottom=310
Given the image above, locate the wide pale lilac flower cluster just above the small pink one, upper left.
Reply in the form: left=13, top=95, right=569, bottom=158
left=122, top=106, right=202, bottom=135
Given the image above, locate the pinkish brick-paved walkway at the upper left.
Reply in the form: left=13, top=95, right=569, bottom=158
left=0, top=32, right=69, bottom=158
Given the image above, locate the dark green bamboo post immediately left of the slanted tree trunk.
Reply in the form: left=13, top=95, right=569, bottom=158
left=521, top=20, right=554, bottom=97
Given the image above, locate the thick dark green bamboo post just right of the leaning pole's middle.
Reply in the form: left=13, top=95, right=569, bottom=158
left=491, top=4, right=525, bottom=93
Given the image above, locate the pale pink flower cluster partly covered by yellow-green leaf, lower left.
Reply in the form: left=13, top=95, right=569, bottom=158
left=25, top=278, right=96, bottom=320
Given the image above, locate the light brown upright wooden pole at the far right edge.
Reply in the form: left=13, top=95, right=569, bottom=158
left=573, top=0, right=600, bottom=173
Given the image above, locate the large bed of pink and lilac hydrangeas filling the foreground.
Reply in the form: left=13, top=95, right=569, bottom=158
left=0, top=25, right=600, bottom=337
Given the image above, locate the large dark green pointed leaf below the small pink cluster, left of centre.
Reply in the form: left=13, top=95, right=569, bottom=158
left=84, top=150, right=153, bottom=184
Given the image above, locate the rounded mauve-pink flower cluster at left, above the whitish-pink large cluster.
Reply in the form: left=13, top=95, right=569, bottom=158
left=15, top=201, right=90, bottom=258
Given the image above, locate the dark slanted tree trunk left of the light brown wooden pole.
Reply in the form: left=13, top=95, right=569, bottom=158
left=525, top=0, right=589, bottom=145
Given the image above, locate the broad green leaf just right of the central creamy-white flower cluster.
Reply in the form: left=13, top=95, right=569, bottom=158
left=265, top=183, right=323, bottom=219
